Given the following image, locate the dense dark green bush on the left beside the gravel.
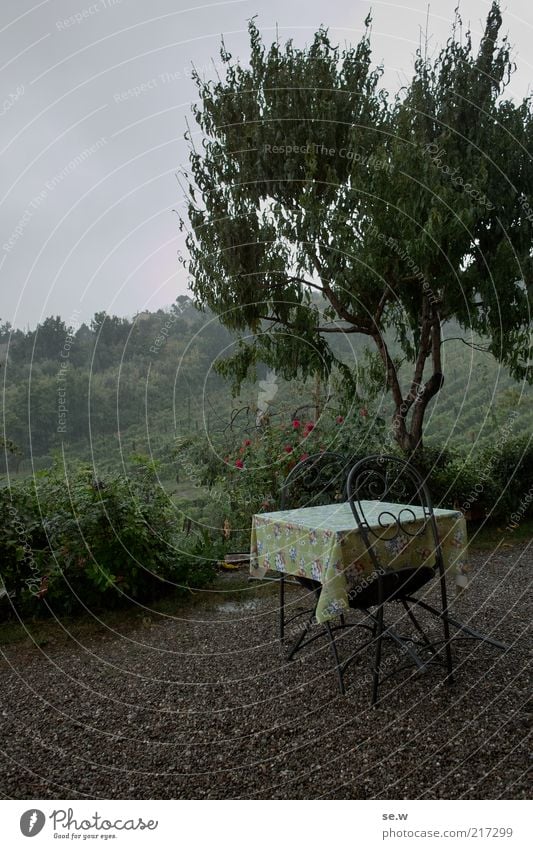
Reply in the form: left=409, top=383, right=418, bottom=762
left=0, top=460, right=214, bottom=612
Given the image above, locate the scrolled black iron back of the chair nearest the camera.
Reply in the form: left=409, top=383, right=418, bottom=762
left=346, top=454, right=444, bottom=574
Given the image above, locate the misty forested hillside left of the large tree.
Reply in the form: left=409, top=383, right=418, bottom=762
left=0, top=297, right=231, bottom=470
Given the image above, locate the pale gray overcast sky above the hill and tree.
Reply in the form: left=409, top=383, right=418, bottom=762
left=0, top=0, right=533, bottom=327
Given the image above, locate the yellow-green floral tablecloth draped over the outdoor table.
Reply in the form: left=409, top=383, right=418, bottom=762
left=250, top=501, right=468, bottom=622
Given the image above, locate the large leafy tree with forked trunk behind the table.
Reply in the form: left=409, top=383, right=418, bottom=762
left=181, top=3, right=533, bottom=453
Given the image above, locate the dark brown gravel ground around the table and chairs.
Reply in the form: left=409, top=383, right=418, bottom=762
left=0, top=546, right=533, bottom=799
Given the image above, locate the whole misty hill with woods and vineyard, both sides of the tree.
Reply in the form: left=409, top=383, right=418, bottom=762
left=0, top=297, right=533, bottom=471
